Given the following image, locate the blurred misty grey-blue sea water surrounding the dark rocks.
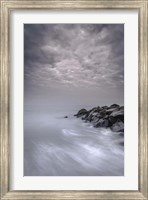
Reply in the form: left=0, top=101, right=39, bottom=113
left=24, top=106, right=124, bottom=176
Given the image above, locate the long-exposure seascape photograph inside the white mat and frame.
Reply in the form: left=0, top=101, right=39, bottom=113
left=24, top=24, right=124, bottom=176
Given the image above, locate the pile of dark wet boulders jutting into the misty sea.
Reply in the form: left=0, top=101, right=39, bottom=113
left=74, top=104, right=124, bottom=134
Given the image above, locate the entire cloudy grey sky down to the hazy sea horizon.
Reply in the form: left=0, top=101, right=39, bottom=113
left=24, top=24, right=124, bottom=106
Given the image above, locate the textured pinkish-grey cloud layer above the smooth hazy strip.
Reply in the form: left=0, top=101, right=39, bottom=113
left=24, top=24, right=124, bottom=105
